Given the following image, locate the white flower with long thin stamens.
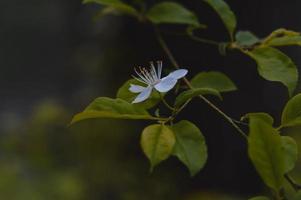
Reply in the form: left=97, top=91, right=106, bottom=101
left=129, top=61, right=188, bottom=103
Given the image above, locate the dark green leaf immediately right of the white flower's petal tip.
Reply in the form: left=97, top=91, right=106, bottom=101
left=191, top=71, right=237, bottom=92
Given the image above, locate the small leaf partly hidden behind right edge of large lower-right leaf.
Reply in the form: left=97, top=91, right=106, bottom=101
left=281, top=136, right=298, bottom=173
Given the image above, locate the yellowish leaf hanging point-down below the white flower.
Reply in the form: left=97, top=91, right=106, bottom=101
left=141, top=124, right=176, bottom=171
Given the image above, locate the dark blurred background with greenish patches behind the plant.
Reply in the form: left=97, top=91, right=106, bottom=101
left=0, top=0, right=301, bottom=200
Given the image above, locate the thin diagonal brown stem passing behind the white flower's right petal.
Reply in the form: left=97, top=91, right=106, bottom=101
left=154, top=26, right=247, bottom=139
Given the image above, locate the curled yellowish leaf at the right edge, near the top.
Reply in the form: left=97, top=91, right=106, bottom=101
left=263, top=28, right=301, bottom=46
